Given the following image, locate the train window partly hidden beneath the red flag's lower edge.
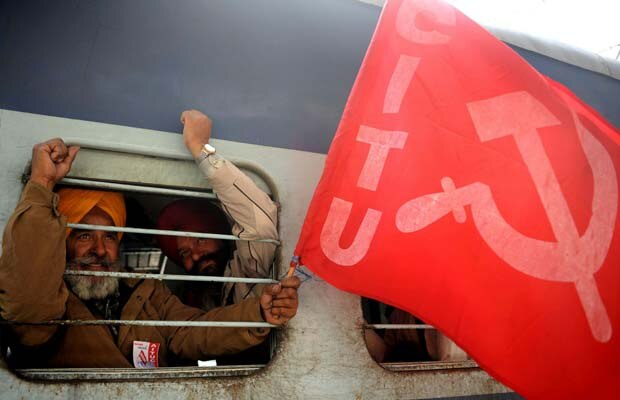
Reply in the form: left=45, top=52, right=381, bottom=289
left=361, top=298, right=477, bottom=371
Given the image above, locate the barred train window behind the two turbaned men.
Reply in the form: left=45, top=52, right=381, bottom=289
left=0, top=144, right=280, bottom=380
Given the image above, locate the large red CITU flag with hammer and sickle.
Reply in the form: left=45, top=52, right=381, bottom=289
left=296, top=0, right=620, bottom=398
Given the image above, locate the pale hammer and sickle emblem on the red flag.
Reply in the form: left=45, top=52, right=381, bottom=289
left=396, top=91, right=618, bottom=342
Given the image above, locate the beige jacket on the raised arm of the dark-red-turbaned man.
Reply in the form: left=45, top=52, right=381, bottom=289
left=199, top=154, right=278, bottom=304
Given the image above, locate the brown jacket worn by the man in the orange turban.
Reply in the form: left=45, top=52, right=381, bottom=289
left=0, top=182, right=269, bottom=367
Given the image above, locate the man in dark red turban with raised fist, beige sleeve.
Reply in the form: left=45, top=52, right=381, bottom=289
left=157, top=110, right=278, bottom=310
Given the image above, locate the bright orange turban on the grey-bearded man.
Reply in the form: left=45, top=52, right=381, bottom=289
left=58, top=188, right=127, bottom=240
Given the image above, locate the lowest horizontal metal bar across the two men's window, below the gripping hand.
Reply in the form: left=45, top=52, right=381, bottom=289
left=0, top=319, right=278, bottom=328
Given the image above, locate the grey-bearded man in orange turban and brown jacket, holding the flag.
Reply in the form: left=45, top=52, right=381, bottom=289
left=0, top=138, right=299, bottom=368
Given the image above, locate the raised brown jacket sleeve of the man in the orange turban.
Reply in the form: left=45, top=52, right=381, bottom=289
left=0, top=182, right=68, bottom=346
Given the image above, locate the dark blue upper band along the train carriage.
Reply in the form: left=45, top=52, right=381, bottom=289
left=0, top=0, right=620, bottom=153
